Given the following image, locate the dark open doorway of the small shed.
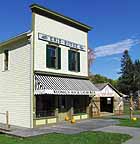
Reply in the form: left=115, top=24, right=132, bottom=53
left=100, top=97, right=113, bottom=113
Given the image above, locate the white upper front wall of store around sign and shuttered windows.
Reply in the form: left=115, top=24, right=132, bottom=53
left=34, top=14, right=88, bottom=76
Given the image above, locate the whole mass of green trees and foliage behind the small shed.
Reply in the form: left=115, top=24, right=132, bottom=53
left=89, top=50, right=140, bottom=96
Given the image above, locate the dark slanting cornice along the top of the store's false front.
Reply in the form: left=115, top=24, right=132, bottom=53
left=30, top=4, right=92, bottom=32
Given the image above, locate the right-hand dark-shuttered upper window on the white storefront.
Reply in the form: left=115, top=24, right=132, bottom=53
left=68, top=50, right=80, bottom=72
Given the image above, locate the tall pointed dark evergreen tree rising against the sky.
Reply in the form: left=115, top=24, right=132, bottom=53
left=118, top=50, right=134, bottom=94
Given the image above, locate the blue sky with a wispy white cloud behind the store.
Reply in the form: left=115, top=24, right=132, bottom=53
left=0, top=0, right=140, bottom=79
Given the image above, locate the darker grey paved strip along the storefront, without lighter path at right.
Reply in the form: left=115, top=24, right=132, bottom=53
left=0, top=119, right=119, bottom=137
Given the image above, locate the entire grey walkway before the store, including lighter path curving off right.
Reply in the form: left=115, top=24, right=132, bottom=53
left=0, top=119, right=140, bottom=144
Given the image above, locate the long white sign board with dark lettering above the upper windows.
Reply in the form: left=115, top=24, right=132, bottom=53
left=38, top=33, right=85, bottom=51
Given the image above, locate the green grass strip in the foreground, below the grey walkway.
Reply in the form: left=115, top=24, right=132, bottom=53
left=0, top=132, right=131, bottom=144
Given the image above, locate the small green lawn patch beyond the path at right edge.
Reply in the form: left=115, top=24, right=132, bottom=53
left=119, top=119, right=140, bottom=128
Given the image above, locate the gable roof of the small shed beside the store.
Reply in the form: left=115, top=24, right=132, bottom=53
left=94, top=83, right=123, bottom=97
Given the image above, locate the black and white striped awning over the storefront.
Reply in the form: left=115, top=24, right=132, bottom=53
left=35, top=74, right=98, bottom=95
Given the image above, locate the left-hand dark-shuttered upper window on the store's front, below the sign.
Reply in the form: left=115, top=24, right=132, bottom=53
left=46, top=45, right=61, bottom=69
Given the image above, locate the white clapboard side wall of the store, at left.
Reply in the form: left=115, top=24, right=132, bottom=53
left=0, top=42, right=31, bottom=127
